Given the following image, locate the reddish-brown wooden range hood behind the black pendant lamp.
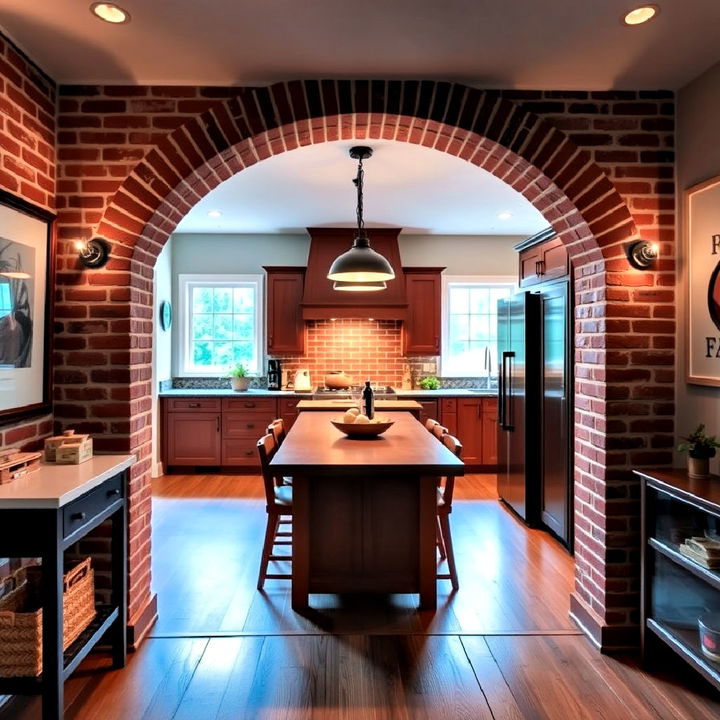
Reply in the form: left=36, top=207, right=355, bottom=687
left=302, top=228, right=407, bottom=320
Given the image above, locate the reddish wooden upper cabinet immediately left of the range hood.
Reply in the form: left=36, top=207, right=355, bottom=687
left=265, top=267, right=305, bottom=355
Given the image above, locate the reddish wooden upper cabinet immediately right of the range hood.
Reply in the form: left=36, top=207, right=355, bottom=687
left=403, top=267, right=445, bottom=355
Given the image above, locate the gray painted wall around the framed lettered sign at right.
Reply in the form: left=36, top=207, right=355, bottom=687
left=675, top=56, right=720, bottom=473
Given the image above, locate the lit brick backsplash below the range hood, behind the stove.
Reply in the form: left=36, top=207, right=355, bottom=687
left=280, top=319, right=406, bottom=387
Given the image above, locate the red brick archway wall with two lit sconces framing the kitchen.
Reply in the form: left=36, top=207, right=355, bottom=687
left=47, top=81, right=675, bottom=644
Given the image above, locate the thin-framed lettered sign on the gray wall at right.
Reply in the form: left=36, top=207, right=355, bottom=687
left=684, top=175, right=720, bottom=386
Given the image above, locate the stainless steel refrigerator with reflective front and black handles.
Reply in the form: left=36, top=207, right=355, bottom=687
left=497, top=292, right=542, bottom=525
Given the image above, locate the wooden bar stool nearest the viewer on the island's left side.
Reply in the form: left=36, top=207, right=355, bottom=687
left=257, top=433, right=292, bottom=590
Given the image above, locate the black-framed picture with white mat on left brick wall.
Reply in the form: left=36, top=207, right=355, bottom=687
left=0, top=190, right=55, bottom=424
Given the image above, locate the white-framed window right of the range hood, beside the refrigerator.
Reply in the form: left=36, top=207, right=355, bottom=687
left=440, top=275, right=517, bottom=377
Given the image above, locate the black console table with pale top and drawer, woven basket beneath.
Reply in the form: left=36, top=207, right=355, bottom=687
left=0, top=455, right=135, bottom=720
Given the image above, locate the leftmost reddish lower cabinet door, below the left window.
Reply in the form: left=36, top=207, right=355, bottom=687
left=166, top=412, right=220, bottom=465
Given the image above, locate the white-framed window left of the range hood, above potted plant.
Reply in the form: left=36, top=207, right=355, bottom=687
left=178, top=275, right=265, bottom=375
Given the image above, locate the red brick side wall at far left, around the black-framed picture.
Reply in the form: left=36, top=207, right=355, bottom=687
left=0, top=35, right=56, bottom=449
